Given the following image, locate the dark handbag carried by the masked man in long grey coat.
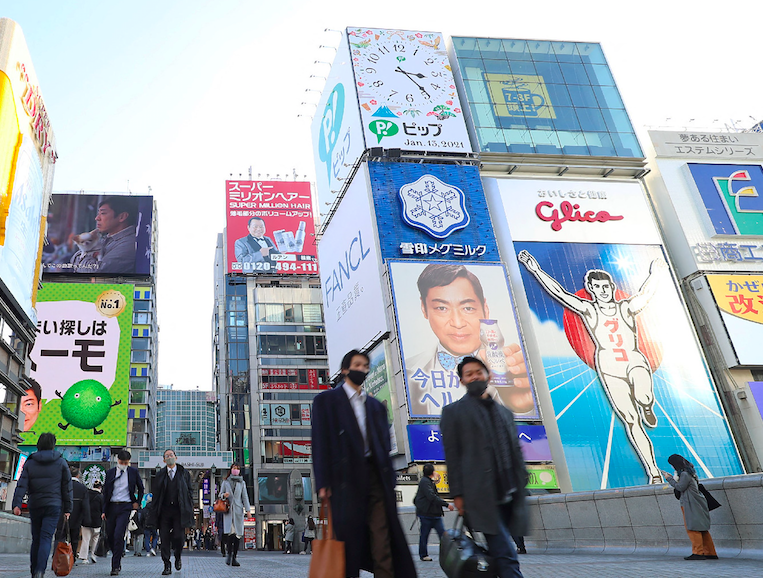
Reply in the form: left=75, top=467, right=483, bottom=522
left=440, top=516, right=495, bottom=578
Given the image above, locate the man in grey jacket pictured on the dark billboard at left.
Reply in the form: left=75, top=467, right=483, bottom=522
left=72, top=196, right=138, bottom=274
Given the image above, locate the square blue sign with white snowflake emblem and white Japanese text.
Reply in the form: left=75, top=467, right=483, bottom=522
left=368, top=162, right=500, bottom=262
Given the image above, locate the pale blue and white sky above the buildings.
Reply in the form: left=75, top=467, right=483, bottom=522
left=0, top=0, right=762, bottom=389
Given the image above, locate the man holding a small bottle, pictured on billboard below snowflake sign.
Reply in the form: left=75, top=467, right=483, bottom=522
left=405, top=263, right=533, bottom=415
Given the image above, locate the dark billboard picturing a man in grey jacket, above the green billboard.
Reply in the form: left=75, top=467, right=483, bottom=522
left=42, top=194, right=154, bottom=277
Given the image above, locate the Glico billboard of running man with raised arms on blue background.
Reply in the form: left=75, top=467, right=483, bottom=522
left=514, top=241, right=743, bottom=491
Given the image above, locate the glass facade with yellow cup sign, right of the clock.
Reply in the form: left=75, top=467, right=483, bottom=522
left=453, top=37, right=643, bottom=158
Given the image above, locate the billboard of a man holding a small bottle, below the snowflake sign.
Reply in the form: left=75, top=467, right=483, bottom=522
left=389, top=261, right=540, bottom=419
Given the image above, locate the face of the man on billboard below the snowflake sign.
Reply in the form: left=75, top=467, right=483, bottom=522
left=421, top=277, right=490, bottom=355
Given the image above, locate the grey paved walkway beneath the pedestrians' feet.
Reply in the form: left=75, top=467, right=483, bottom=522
left=0, top=548, right=763, bottom=578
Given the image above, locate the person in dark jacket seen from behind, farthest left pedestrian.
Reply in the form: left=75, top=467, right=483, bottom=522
left=13, top=433, right=72, bottom=578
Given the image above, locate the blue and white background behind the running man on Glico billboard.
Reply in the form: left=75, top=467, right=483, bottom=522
left=514, top=242, right=744, bottom=491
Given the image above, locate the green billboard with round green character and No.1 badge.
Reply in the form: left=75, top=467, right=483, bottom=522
left=21, top=283, right=133, bottom=446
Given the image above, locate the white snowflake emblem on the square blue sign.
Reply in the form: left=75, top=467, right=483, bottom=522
left=400, top=175, right=469, bottom=239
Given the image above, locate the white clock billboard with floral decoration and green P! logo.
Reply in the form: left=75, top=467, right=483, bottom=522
left=347, top=28, right=472, bottom=153
